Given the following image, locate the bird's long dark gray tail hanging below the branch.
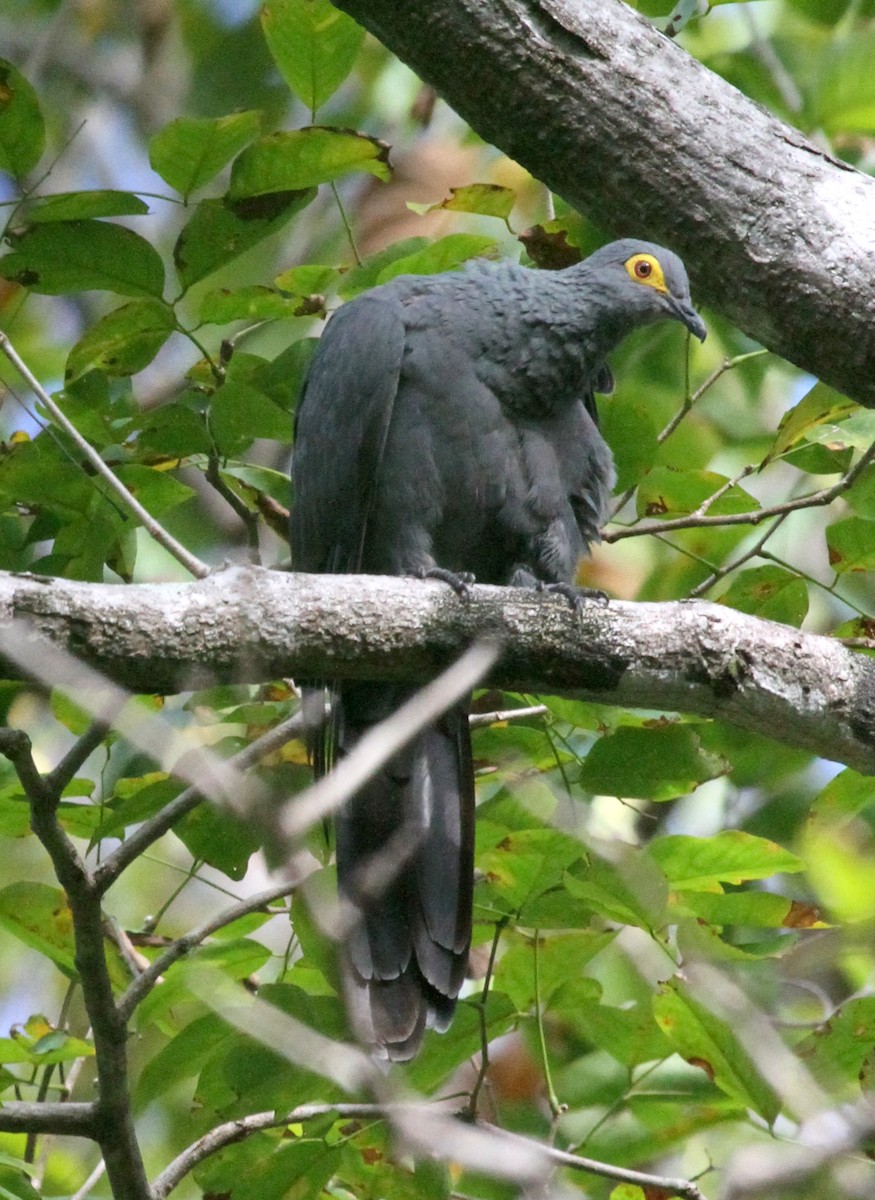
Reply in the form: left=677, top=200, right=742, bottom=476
left=334, top=683, right=474, bottom=1060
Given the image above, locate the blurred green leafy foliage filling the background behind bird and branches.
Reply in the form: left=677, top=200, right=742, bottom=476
left=0, top=0, right=875, bottom=1200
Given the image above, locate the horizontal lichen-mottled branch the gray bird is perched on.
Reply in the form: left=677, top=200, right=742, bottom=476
left=0, top=566, right=875, bottom=773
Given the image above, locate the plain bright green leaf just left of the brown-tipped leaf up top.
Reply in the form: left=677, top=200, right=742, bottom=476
left=149, top=110, right=262, bottom=199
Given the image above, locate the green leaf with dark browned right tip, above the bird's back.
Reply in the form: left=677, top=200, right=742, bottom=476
left=229, top=125, right=389, bottom=200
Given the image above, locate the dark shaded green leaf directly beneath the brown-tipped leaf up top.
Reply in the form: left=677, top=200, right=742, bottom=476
left=172, top=190, right=316, bottom=288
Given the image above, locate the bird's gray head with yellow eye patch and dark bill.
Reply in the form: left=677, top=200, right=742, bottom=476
left=585, top=238, right=707, bottom=342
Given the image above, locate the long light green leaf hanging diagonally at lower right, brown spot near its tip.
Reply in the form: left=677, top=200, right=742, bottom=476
left=653, top=979, right=780, bottom=1124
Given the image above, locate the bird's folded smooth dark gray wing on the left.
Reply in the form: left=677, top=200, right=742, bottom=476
left=290, top=295, right=404, bottom=572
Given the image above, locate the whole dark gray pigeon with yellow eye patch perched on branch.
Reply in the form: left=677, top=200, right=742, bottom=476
left=290, top=239, right=706, bottom=1060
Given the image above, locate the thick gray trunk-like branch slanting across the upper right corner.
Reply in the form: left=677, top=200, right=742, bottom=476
left=336, top=0, right=875, bottom=404
